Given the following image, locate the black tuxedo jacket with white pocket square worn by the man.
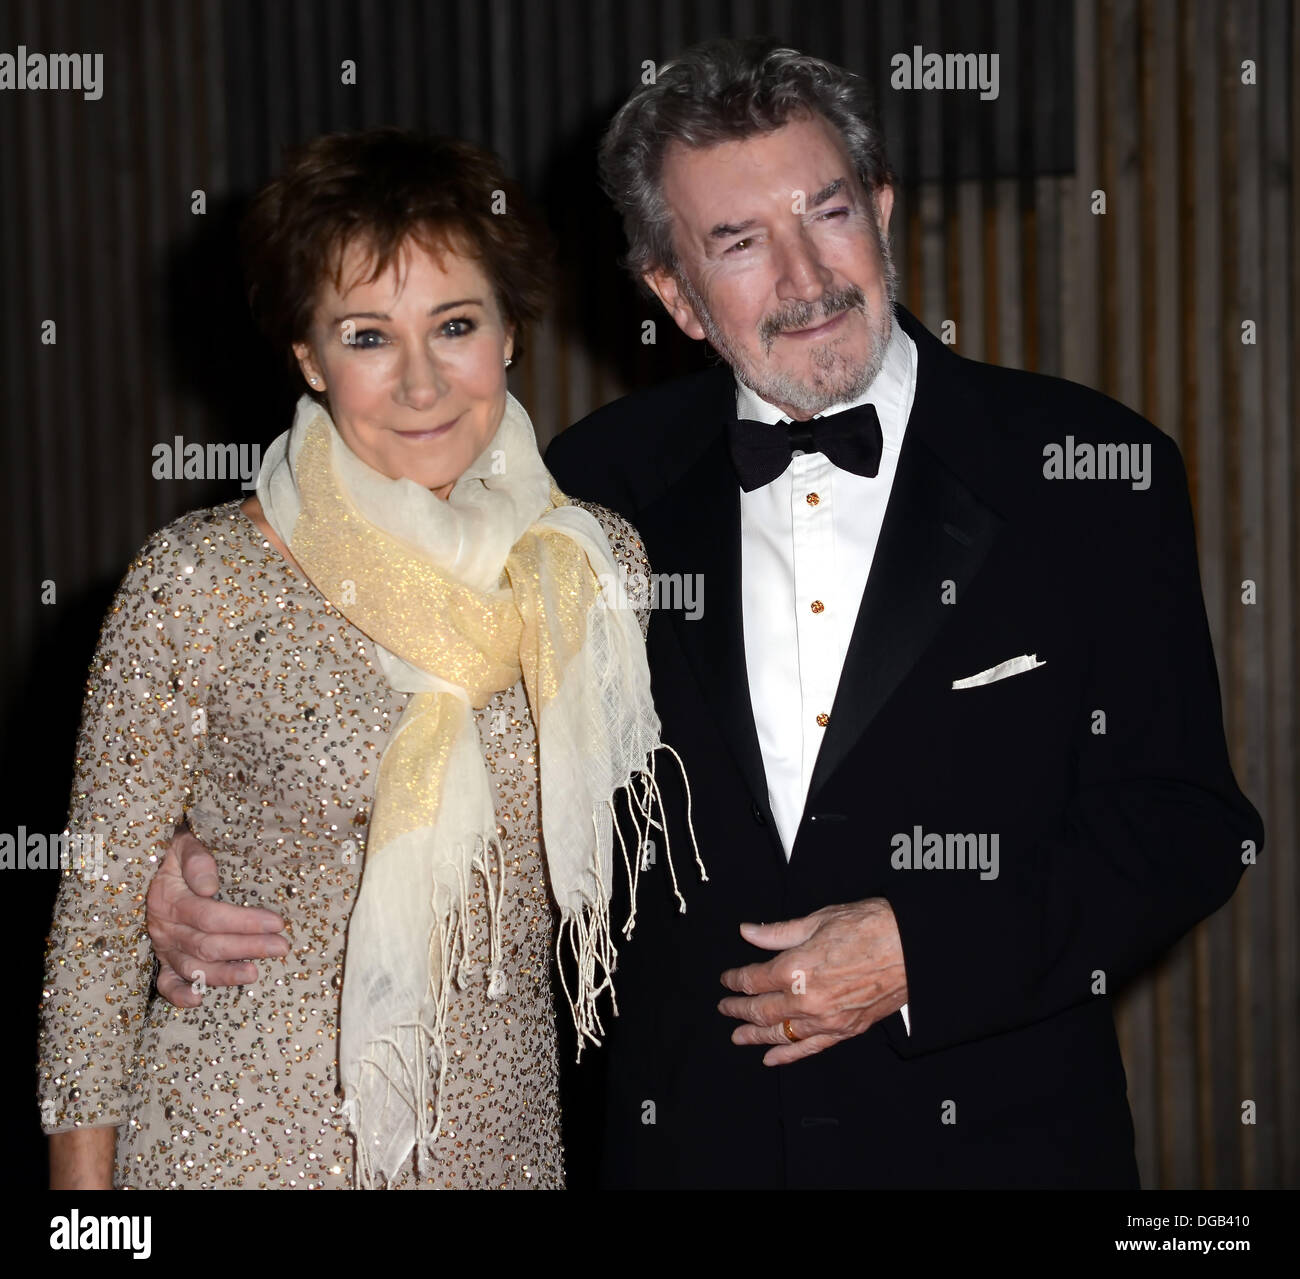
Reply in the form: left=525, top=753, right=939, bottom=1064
left=546, top=308, right=1262, bottom=1187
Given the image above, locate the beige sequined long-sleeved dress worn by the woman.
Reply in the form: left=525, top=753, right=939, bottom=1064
left=39, top=502, right=649, bottom=1189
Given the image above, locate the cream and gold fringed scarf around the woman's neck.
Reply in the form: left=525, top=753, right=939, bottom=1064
left=257, top=395, right=703, bottom=1187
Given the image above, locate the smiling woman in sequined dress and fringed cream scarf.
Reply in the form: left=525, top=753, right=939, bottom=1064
left=40, top=130, right=691, bottom=1188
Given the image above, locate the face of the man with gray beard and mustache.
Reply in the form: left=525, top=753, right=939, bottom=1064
left=645, top=116, right=894, bottom=420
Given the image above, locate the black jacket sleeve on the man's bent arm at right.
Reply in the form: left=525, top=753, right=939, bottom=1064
left=884, top=434, right=1264, bottom=1057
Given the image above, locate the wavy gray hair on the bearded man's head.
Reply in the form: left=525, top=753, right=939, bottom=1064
left=601, top=36, right=893, bottom=281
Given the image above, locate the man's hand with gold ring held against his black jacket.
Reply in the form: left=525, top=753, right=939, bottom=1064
left=718, top=897, right=907, bottom=1066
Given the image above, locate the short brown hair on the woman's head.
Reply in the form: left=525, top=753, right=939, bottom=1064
left=241, top=127, right=553, bottom=382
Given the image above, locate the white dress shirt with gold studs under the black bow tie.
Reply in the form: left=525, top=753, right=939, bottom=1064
left=736, top=320, right=917, bottom=1032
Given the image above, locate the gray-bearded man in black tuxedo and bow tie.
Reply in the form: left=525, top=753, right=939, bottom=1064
left=151, top=42, right=1262, bottom=1187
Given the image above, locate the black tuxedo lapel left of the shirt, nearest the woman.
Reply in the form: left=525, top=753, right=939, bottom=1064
left=638, top=426, right=784, bottom=837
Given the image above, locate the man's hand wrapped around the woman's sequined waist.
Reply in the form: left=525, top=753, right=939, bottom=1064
left=146, top=831, right=290, bottom=1009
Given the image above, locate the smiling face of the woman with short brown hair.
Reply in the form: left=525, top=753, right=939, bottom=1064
left=294, top=240, right=514, bottom=498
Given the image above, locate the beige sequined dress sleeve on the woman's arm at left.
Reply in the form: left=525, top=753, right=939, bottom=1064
left=38, top=534, right=202, bottom=1133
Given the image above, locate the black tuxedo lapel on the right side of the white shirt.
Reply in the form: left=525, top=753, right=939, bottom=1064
left=809, top=308, right=1002, bottom=807
